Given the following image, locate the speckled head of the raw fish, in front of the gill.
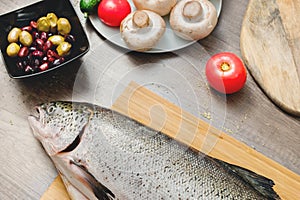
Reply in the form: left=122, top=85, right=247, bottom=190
left=28, top=101, right=93, bottom=156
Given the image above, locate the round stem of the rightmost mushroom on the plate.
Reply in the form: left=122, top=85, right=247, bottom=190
left=182, top=1, right=203, bottom=20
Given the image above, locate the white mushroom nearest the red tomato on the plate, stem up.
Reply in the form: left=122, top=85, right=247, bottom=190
left=120, top=10, right=166, bottom=51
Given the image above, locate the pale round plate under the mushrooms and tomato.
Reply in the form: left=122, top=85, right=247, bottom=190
left=89, top=0, right=222, bottom=53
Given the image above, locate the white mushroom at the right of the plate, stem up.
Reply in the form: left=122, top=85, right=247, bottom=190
left=170, top=0, right=218, bottom=40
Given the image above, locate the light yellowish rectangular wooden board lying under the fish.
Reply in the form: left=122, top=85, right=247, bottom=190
left=42, top=82, right=300, bottom=200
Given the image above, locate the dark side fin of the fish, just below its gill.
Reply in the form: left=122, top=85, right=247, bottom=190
left=70, top=161, right=115, bottom=200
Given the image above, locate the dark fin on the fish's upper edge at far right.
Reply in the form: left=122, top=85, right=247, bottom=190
left=214, top=159, right=280, bottom=200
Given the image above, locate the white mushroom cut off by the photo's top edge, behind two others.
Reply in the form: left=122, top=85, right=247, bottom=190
left=133, top=0, right=177, bottom=16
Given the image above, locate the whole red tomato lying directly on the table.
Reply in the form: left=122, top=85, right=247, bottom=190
left=205, top=52, right=247, bottom=94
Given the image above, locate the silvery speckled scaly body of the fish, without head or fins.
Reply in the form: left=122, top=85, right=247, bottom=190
left=68, top=109, right=264, bottom=200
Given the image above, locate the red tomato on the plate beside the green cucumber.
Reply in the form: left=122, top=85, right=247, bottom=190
left=98, top=0, right=131, bottom=26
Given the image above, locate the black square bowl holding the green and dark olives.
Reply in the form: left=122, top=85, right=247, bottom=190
left=0, top=0, right=89, bottom=78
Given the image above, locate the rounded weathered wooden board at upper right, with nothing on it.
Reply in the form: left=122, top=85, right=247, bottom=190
left=240, top=0, right=300, bottom=116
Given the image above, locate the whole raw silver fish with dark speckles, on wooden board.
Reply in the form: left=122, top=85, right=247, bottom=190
left=29, top=102, right=279, bottom=200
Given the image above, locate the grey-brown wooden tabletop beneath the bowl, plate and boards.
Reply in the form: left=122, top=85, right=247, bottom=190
left=0, top=0, right=300, bottom=199
